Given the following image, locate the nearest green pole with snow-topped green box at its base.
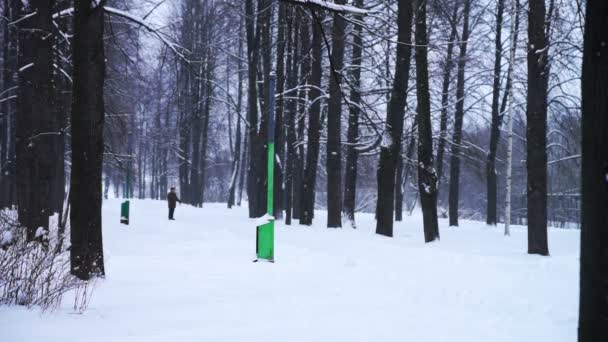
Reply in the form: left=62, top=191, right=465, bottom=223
left=256, top=74, right=276, bottom=262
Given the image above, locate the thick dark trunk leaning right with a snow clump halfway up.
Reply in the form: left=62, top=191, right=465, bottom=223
left=376, top=0, right=414, bottom=237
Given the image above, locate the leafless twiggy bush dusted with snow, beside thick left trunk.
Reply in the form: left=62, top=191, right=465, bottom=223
left=0, top=211, right=87, bottom=311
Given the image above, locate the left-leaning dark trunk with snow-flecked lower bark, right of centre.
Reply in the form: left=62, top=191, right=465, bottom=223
left=415, top=0, right=439, bottom=242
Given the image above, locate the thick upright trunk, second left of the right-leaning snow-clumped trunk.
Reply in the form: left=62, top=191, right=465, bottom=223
left=326, top=0, right=346, bottom=228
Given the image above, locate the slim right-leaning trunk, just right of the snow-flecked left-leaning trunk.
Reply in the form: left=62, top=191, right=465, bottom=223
left=448, top=0, right=471, bottom=226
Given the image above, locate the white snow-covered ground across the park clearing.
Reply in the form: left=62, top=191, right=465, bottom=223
left=0, top=200, right=579, bottom=342
